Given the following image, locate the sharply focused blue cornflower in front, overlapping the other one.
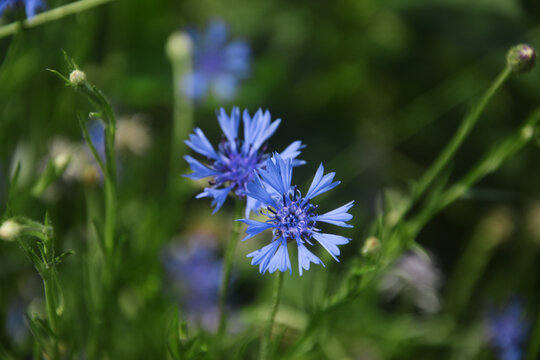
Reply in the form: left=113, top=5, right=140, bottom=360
left=239, top=154, right=354, bottom=276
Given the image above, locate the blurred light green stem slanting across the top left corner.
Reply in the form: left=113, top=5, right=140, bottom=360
left=0, top=0, right=113, bottom=38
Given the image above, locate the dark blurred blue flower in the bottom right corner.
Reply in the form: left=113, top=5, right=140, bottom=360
left=488, top=299, right=529, bottom=360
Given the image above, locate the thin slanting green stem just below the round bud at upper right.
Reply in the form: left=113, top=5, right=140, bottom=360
left=413, top=67, right=512, bottom=200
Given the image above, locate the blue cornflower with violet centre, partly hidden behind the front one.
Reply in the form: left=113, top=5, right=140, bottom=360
left=184, top=107, right=305, bottom=217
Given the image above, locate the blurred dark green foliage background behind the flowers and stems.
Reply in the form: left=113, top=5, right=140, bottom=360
left=0, top=0, right=540, bottom=359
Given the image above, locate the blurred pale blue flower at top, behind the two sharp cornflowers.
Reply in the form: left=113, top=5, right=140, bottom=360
left=181, top=20, right=251, bottom=100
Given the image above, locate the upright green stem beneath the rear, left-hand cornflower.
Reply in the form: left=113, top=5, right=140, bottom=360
left=218, top=199, right=244, bottom=338
